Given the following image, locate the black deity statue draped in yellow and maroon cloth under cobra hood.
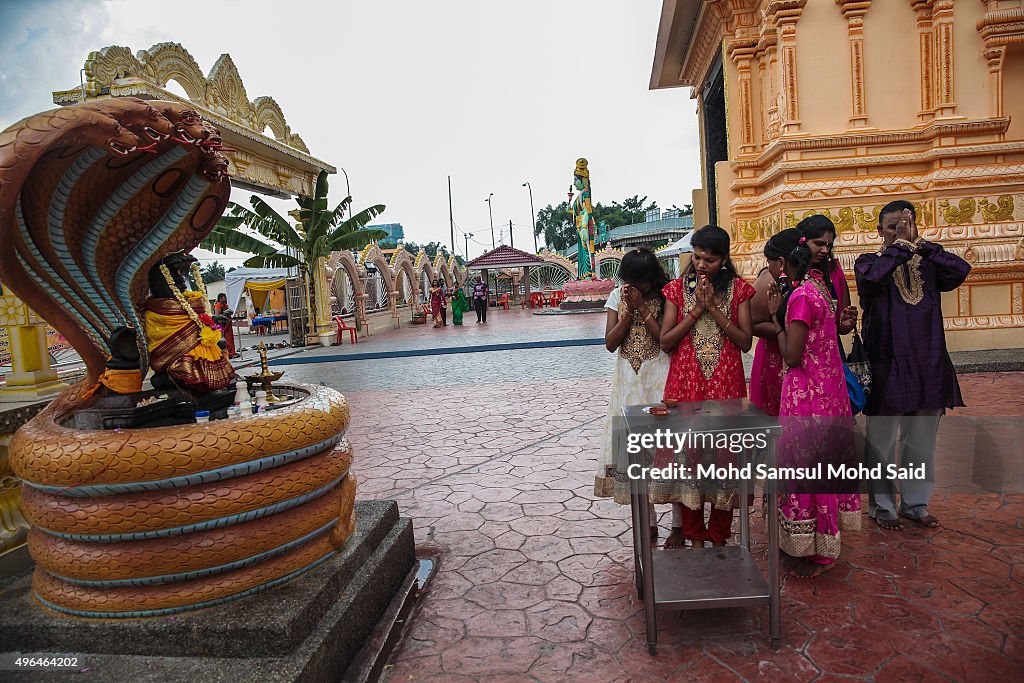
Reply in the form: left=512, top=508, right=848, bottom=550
left=143, top=252, right=234, bottom=392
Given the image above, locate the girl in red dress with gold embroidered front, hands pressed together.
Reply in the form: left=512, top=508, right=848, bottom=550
left=651, top=225, right=754, bottom=548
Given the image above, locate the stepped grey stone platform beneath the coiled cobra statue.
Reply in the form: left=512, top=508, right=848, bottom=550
left=0, top=501, right=416, bottom=681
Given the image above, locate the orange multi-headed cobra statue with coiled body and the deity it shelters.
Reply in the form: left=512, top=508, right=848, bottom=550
left=0, top=97, right=355, bottom=617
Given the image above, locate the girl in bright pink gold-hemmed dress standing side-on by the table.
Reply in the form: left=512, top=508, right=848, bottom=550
left=768, top=229, right=860, bottom=577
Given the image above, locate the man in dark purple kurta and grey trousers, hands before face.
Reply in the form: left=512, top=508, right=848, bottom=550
left=854, top=200, right=971, bottom=530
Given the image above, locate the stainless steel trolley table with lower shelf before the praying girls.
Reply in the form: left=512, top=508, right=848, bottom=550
left=621, top=398, right=781, bottom=654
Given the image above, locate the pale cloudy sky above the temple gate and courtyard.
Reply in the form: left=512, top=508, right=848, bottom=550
left=0, top=0, right=699, bottom=265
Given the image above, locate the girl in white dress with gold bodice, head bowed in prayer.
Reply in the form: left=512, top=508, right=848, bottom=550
left=594, top=248, right=670, bottom=539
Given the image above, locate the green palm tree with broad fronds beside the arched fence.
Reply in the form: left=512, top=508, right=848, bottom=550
left=200, top=171, right=387, bottom=342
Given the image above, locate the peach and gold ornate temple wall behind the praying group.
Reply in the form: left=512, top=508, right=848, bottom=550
left=650, top=0, right=1024, bottom=350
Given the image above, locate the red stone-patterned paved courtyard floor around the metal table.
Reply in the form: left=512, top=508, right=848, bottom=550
left=274, top=311, right=1024, bottom=682
